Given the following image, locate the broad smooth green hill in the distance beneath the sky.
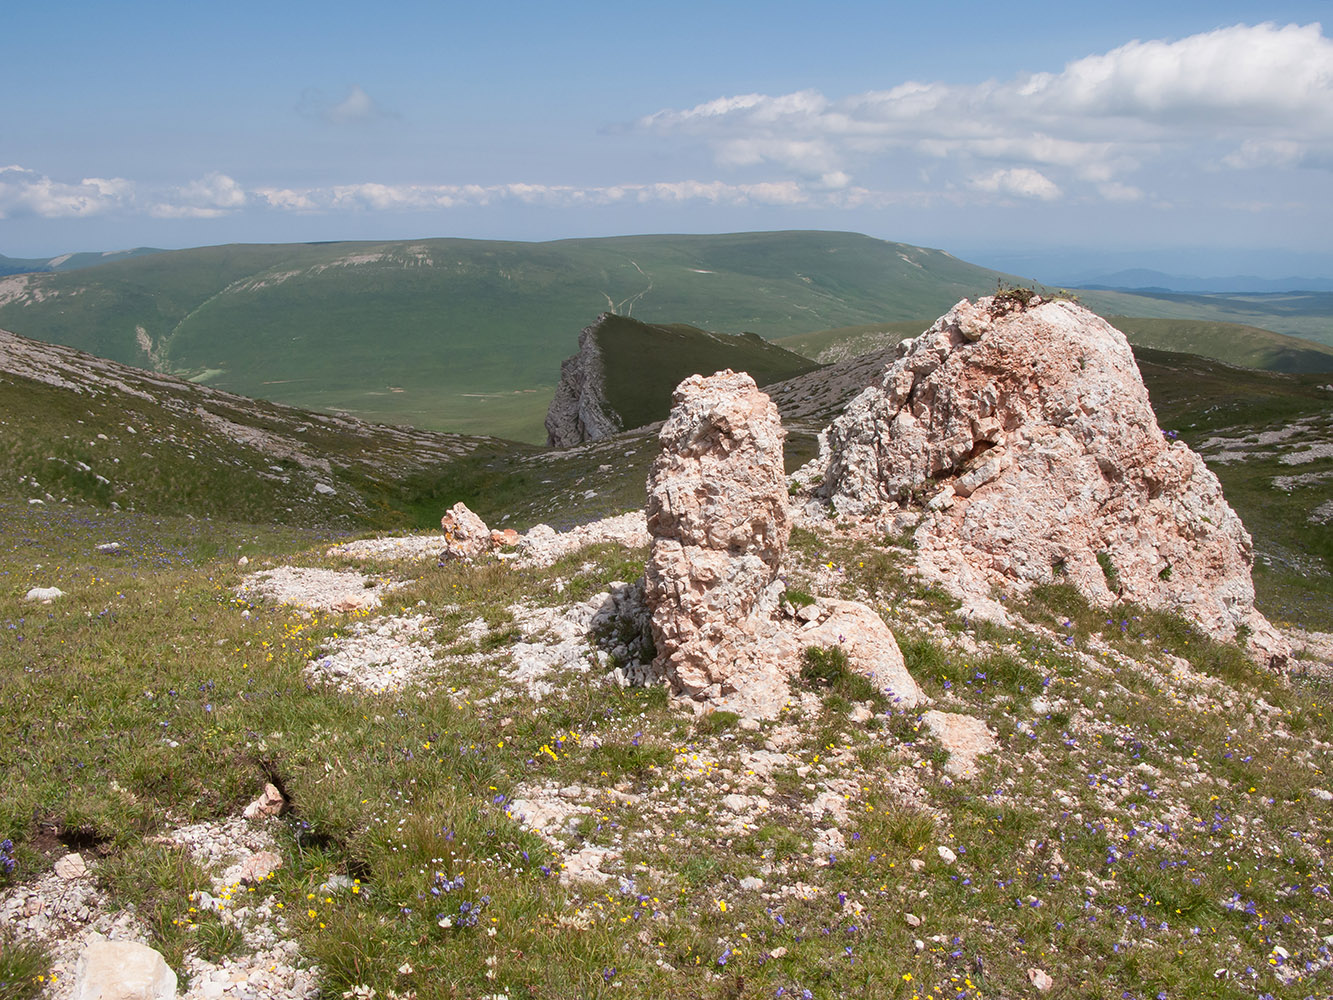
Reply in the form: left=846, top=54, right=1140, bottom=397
left=0, top=232, right=1018, bottom=440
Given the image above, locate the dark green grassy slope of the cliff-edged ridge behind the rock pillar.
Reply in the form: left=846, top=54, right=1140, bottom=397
left=596, top=316, right=818, bottom=428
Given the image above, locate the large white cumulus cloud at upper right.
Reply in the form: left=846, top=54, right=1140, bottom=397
left=639, top=24, right=1333, bottom=200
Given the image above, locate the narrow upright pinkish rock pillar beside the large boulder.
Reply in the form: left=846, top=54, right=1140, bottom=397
left=645, top=369, right=792, bottom=697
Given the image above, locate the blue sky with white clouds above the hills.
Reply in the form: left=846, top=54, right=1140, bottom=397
left=0, top=0, right=1333, bottom=276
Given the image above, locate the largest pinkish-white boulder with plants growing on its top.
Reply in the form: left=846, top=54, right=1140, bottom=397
left=818, top=296, right=1288, bottom=674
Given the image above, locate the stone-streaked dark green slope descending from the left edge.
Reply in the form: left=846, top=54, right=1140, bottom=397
left=0, top=331, right=533, bottom=529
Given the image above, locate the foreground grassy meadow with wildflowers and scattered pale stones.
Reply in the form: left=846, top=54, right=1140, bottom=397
left=0, top=453, right=1333, bottom=1000
